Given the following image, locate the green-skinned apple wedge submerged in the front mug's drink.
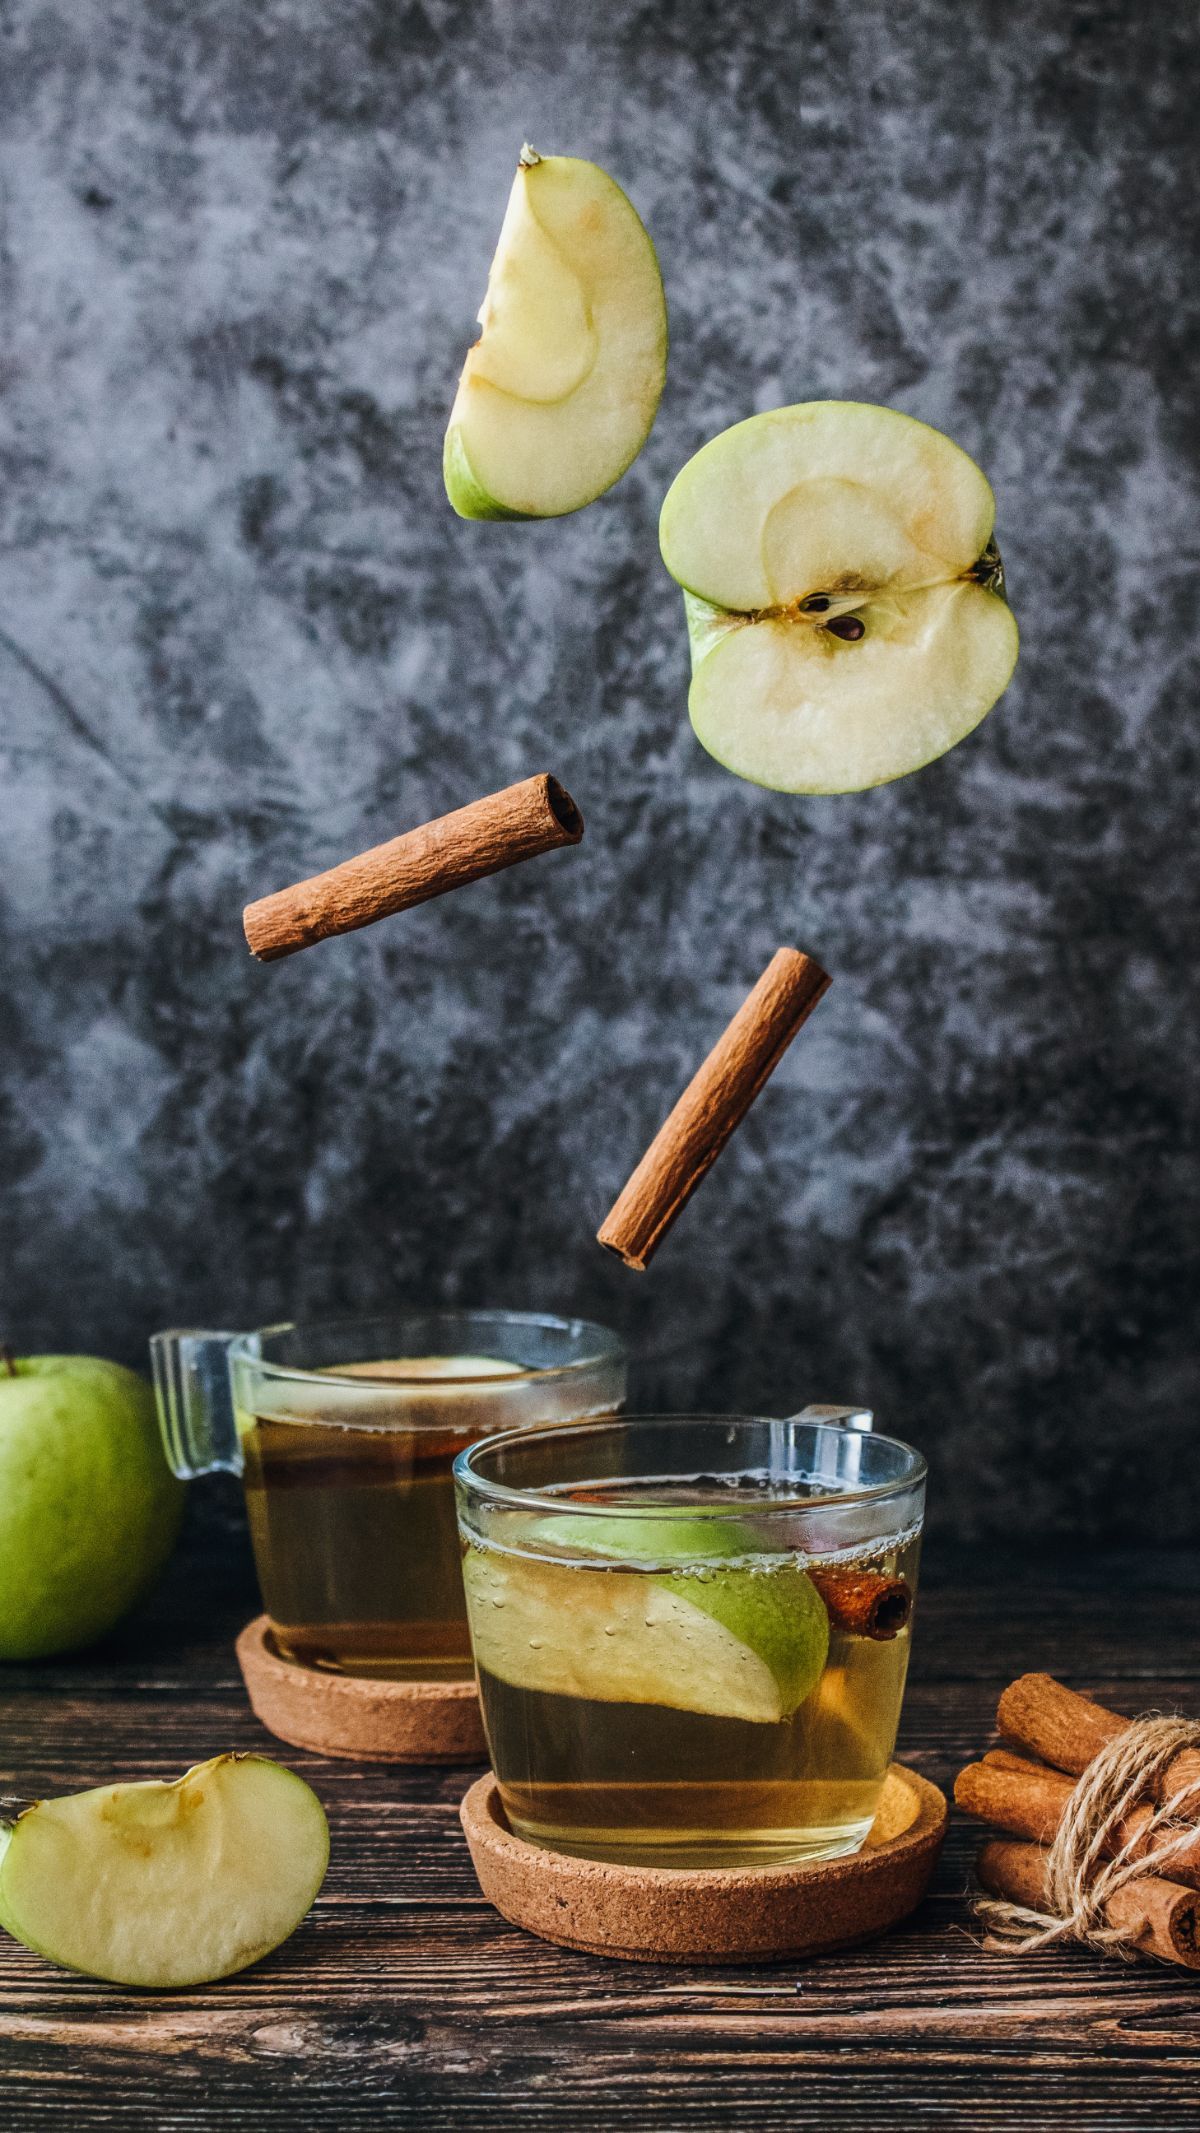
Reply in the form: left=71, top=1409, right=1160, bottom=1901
left=463, top=1517, right=829, bottom=1726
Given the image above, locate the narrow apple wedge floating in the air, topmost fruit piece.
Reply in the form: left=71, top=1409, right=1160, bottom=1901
left=443, top=147, right=667, bottom=518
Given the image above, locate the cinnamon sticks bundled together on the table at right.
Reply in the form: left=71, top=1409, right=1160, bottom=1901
left=955, top=1674, right=1200, bottom=1971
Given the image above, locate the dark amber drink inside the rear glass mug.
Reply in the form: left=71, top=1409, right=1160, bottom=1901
left=241, top=1357, right=520, bottom=1681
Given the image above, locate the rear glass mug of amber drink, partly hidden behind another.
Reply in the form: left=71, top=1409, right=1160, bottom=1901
left=149, top=1310, right=625, bottom=1681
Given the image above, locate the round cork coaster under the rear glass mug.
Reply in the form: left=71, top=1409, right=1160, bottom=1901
left=237, top=1615, right=488, bottom=1762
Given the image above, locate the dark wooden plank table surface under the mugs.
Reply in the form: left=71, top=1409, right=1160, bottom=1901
left=0, top=1501, right=1200, bottom=2133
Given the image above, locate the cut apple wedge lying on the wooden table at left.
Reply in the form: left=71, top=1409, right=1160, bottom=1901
left=0, top=1755, right=328, bottom=1988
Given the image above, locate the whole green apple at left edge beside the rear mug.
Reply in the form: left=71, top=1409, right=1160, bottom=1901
left=0, top=1354, right=183, bottom=1659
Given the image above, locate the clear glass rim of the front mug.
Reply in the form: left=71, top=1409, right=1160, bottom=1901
left=454, top=1414, right=929, bottom=1523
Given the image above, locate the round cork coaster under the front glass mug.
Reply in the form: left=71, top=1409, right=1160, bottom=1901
left=460, top=1762, right=946, bottom=1962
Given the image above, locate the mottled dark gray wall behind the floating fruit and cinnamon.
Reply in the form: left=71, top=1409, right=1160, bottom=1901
left=0, top=0, right=1200, bottom=1538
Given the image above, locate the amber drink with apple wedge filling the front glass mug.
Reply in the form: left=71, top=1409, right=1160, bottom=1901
left=465, top=1493, right=921, bottom=1866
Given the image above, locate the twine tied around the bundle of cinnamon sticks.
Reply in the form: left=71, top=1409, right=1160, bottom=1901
left=976, top=1715, right=1200, bottom=1962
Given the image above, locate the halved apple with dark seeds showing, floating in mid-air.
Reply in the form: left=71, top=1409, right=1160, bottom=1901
left=659, top=401, right=1017, bottom=793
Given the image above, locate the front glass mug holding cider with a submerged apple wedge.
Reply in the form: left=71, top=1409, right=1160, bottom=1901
left=454, top=1410, right=925, bottom=1866
